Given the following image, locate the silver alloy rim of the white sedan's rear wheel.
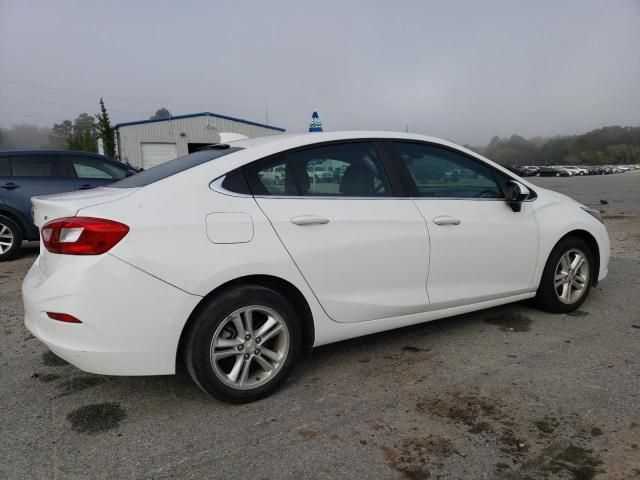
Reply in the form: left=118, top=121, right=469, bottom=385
left=209, top=305, right=290, bottom=390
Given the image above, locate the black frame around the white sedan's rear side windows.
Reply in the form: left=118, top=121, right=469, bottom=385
left=235, top=137, right=408, bottom=200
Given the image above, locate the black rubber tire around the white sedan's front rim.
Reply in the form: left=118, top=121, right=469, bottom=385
left=535, top=237, right=595, bottom=313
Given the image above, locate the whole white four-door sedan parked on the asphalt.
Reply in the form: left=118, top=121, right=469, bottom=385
left=23, top=132, right=609, bottom=402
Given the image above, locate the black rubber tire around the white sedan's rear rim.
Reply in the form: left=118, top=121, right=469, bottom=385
left=183, top=285, right=302, bottom=403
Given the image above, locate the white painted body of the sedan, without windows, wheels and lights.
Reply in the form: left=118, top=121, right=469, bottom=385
left=23, top=132, right=609, bottom=375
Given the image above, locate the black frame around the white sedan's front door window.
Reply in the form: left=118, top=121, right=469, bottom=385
left=384, top=138, right=538, bottom=202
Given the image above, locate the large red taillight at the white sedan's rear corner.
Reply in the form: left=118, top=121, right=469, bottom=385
left=41, top=217, right=129, bottom=255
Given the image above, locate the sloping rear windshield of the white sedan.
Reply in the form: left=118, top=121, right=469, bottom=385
left=109, top=147, right=242, bottom=188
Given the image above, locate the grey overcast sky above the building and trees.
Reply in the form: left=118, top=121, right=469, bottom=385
left=0, top=0, right=640, bottom=144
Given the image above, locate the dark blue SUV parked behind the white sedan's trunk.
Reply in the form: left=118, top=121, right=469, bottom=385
left=0, top=150, right=136, bottom=262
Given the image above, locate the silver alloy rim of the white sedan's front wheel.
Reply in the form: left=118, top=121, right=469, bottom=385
left=554, top=248, right=589, bottom=304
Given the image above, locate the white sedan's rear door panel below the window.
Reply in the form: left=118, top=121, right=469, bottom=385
left=257, top=197, right=429, bottom=322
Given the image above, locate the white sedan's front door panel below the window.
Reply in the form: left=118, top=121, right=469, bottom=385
left=414, top=198, right=539, bottom=306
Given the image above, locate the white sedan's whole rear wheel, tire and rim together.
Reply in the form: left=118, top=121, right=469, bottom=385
left=184, top=285, right=302, bottom=403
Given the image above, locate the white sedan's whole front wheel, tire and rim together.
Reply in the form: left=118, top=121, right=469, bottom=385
left=536, top=237, right=594, bottom=313
